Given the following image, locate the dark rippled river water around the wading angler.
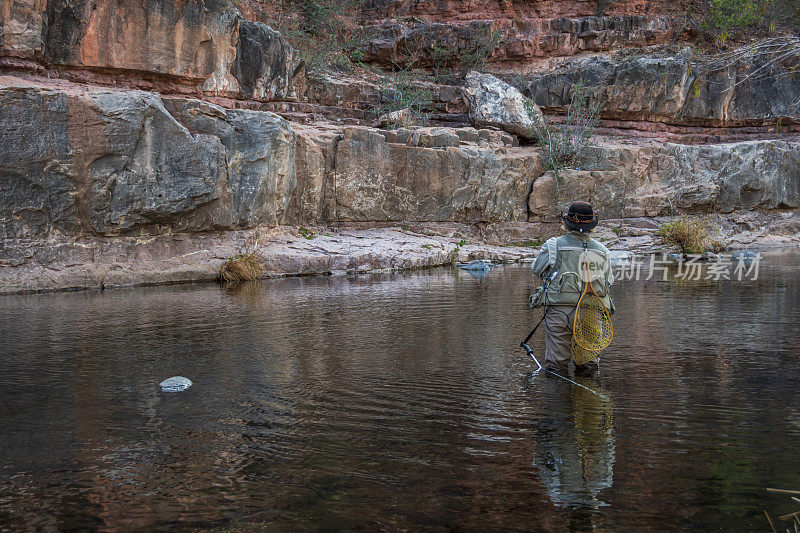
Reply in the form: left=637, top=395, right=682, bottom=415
left=0, top=254, right=800, bottom=531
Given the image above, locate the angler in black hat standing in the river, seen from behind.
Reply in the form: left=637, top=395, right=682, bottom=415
left=531, top=202, right=614, bottom=376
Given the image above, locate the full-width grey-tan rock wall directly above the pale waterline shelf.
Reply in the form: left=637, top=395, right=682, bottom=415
left=0, top=77, right=800, bottom=238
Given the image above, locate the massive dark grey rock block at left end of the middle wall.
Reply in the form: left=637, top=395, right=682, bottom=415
left=0, top=76, right=296, bottom=238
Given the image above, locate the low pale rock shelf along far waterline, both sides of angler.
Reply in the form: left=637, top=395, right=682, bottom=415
left=6, top=212, right=800, bottom=293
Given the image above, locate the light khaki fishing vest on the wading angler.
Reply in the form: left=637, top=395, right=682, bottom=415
left=531, top=234, right=614, bottom=310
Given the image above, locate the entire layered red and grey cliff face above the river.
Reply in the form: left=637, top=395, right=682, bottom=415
left=0, top=0, right=800, bottom=292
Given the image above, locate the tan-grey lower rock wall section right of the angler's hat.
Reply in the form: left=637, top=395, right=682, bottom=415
left=529, top=141, right=800, bottom=219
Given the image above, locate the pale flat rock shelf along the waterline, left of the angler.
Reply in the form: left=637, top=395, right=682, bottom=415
left=0, top=227, right=534, bottom=293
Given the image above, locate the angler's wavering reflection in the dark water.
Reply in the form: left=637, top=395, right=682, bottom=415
left=534, top=377, right=614, bottom=509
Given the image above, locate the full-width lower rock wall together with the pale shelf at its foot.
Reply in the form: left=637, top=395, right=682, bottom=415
left=0, top=71, right=800, bottom=292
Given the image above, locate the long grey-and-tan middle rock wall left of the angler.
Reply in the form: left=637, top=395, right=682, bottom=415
left=0, top=77, right=541, bottom=238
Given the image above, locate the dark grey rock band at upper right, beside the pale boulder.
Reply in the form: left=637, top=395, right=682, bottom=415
left=528, top=43, right=800, bottom=126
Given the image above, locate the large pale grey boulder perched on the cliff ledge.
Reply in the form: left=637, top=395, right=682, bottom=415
left=463, top=72, right=544, bottom=139
